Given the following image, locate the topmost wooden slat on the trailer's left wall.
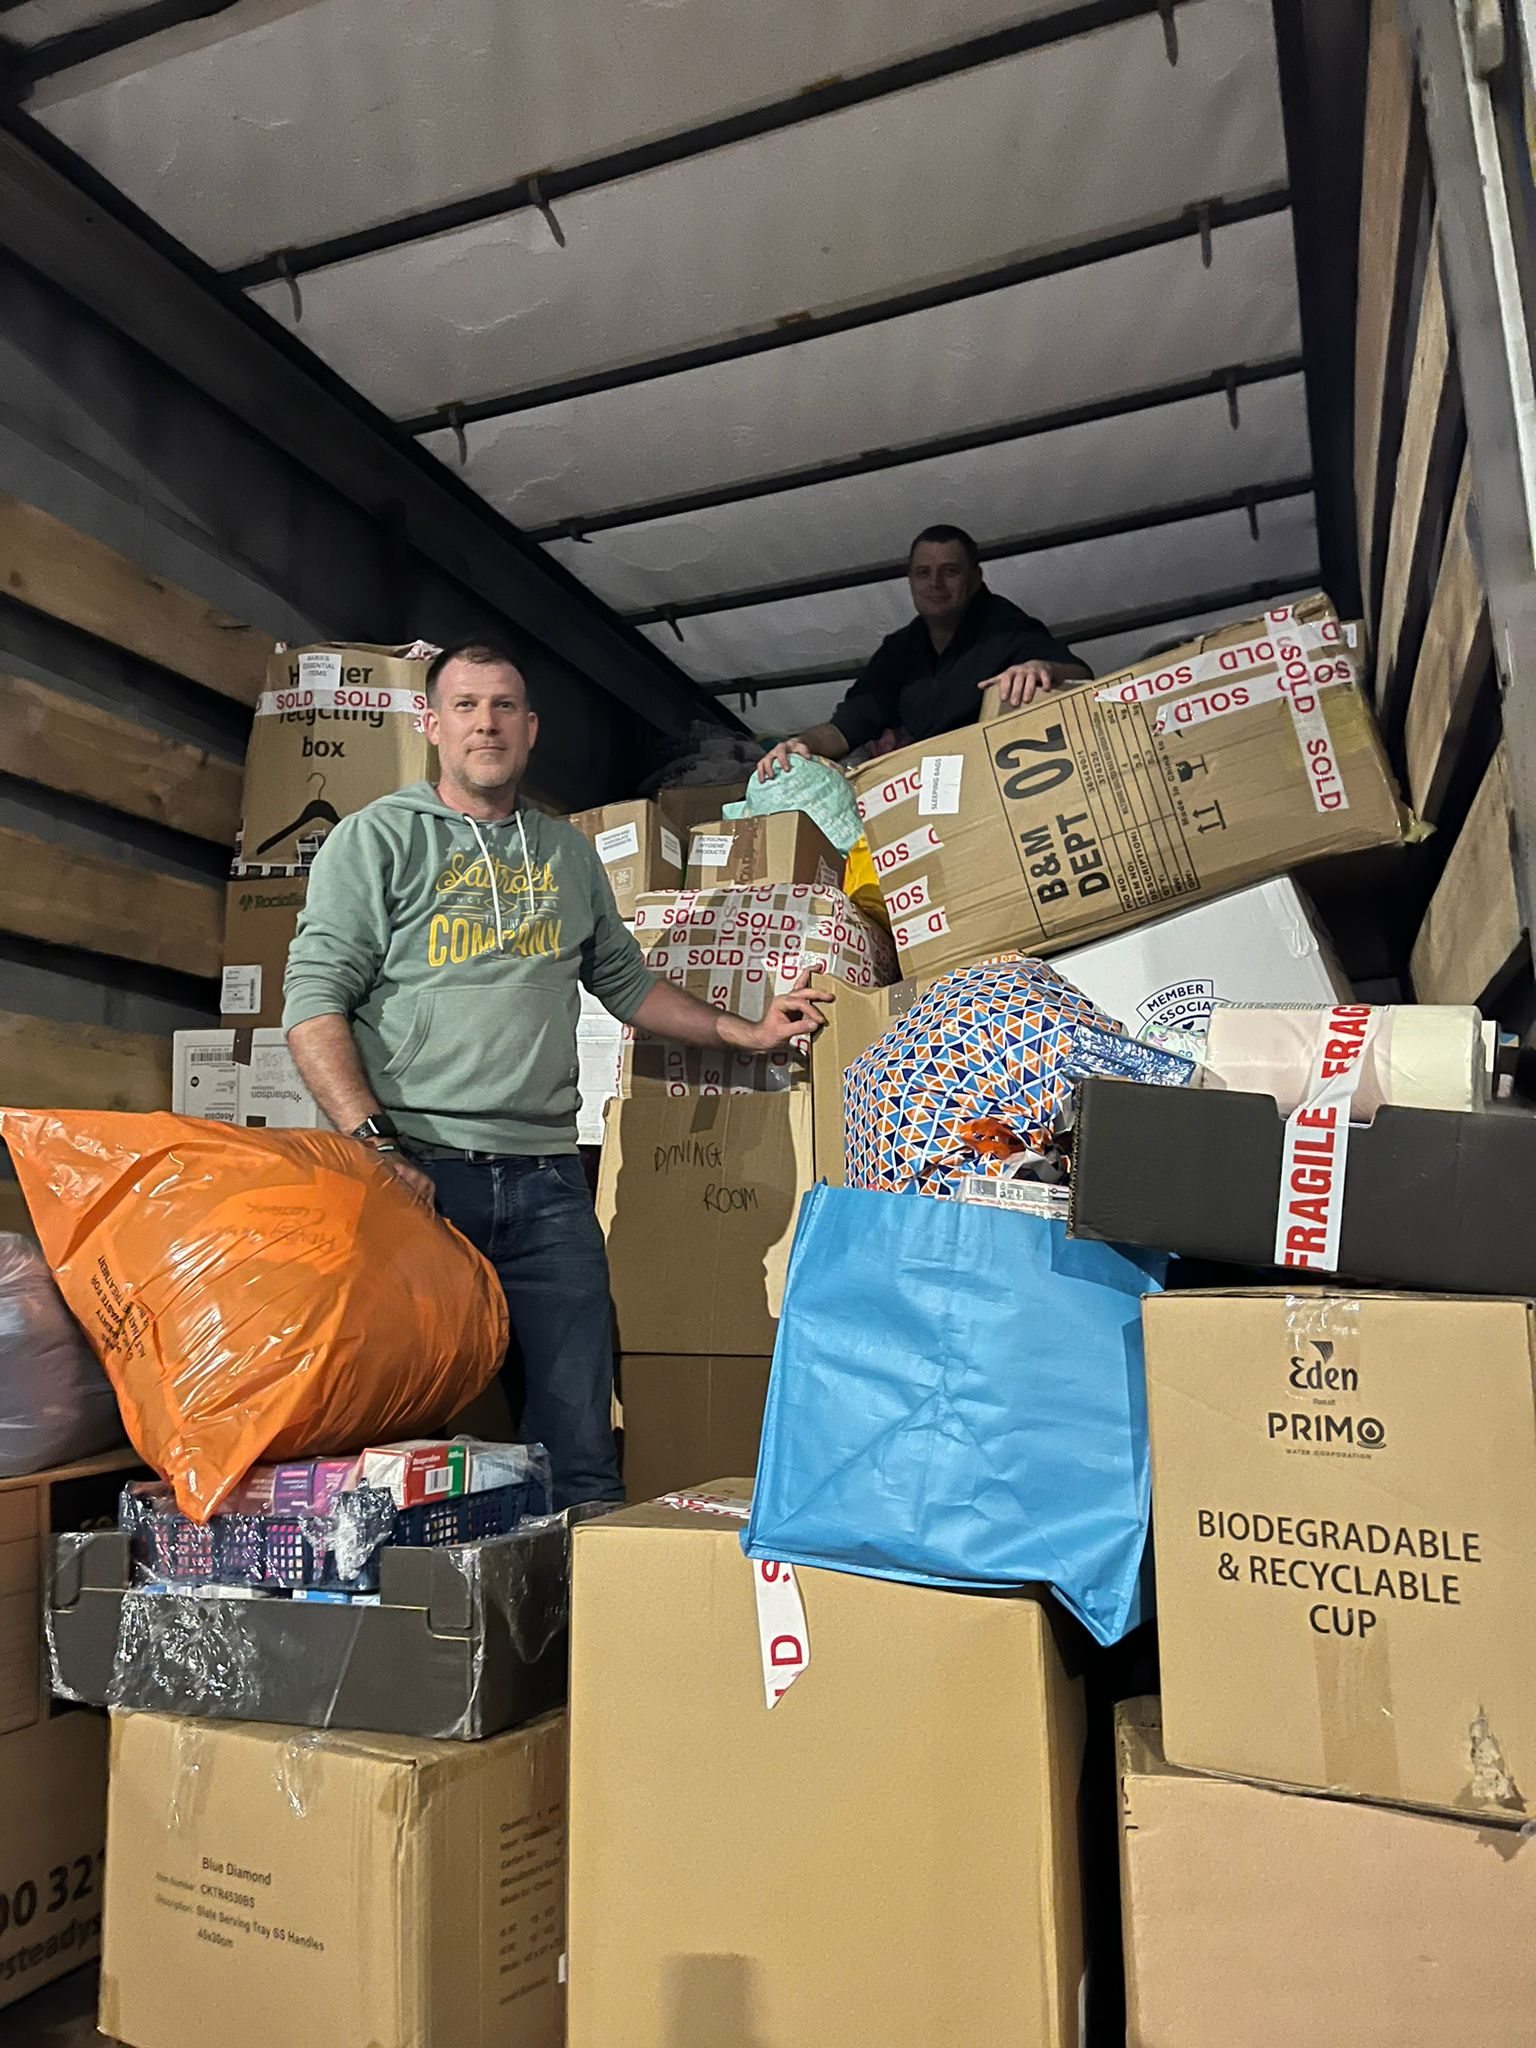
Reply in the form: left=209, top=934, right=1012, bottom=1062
left=0, top=492, right=270, bottom=705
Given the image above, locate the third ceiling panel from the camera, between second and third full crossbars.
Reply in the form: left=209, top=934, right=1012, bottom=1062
left=422, top=215, right=1300, bottom=526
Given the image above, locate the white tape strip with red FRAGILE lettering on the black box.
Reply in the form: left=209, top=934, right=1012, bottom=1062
left=1274, top=1004, right=1380, bottom=1274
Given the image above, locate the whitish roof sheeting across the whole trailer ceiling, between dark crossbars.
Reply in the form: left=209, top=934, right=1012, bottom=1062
left=27, top=0, right=1317, bottom=729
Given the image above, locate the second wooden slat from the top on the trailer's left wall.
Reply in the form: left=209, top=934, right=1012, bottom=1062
left=0, top=674, right=240, bottom=846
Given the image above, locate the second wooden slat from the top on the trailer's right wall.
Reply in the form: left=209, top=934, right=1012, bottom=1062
left=1376, top=227, right=1460, bottom=731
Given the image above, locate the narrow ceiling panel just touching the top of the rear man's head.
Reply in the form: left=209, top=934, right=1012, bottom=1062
left=549, top=377, right=1311, bottom=610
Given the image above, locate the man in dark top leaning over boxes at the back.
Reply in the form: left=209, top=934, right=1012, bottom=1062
left=758, top=526, right=1092, bottom=782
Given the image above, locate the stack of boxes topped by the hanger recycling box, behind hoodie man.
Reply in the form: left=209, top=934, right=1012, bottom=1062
left=172, top=645, right=436, bottom=1128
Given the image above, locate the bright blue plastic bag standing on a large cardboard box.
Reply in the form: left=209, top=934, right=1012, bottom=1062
left=743, top=1186, right=1165, bottom=1642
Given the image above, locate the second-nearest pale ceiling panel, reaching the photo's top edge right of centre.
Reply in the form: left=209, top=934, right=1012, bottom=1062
left=222, top=0, right=1284, bottom=416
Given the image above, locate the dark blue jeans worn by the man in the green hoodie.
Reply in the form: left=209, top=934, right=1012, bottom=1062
left=422, top=1153, right=625, bottom=1507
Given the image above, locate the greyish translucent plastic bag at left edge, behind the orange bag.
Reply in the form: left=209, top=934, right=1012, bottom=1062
left=0, top=1231, right=123, bottom=1479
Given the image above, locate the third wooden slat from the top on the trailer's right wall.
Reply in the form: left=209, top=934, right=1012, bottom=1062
left=1403, top=457, right=1491, bottom=821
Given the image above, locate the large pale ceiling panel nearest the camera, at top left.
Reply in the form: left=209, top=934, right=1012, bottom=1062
left=27, top=0, right=1063, bottom=268
